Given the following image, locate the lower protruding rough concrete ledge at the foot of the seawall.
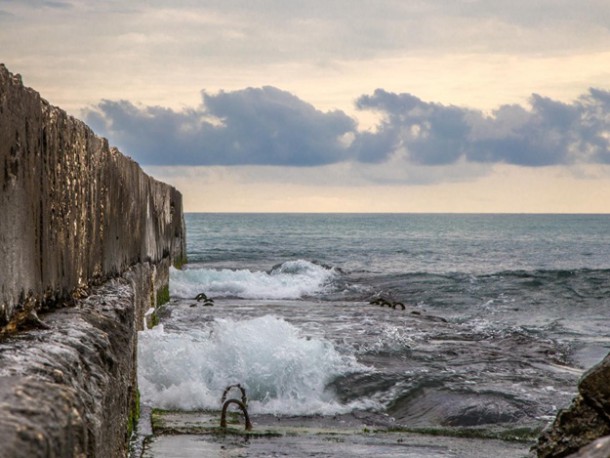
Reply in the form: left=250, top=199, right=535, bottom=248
left=0, top=280, right=136, bottom=458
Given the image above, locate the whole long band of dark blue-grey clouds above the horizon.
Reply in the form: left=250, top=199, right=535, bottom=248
left=86, top=87, right=610, bottom=167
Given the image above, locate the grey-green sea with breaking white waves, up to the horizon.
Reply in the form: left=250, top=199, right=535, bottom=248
left=138, top=213, right=610, bottom=456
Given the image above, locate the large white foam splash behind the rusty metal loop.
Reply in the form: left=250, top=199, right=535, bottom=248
left=138, top=315, right=376, bottom=415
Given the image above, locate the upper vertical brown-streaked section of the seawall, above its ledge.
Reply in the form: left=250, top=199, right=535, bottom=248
left=0, top=65, right=184, bottom=327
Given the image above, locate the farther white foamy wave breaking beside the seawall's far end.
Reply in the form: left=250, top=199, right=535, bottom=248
left=170, top=260, right=337, bottom=299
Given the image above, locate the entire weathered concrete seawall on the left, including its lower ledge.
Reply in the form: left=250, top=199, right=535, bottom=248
left=0, top=65, right=185, bottom=457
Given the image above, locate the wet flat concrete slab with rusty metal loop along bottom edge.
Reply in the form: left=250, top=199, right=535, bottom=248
left=134, top=411, right=531, bottom=458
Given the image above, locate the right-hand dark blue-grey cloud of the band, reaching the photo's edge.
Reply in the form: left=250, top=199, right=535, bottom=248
left=356, top=89, right=610, bottom=166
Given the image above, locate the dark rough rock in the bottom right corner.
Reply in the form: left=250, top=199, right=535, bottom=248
left=536, top=355, right=610, bottom=458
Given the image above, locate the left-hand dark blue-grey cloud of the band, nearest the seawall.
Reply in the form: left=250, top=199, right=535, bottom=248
left=86, top=87, right=355, bottom=166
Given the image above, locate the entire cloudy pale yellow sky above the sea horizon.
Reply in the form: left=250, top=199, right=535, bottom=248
left=0, top=0, right=610, bottom=213
